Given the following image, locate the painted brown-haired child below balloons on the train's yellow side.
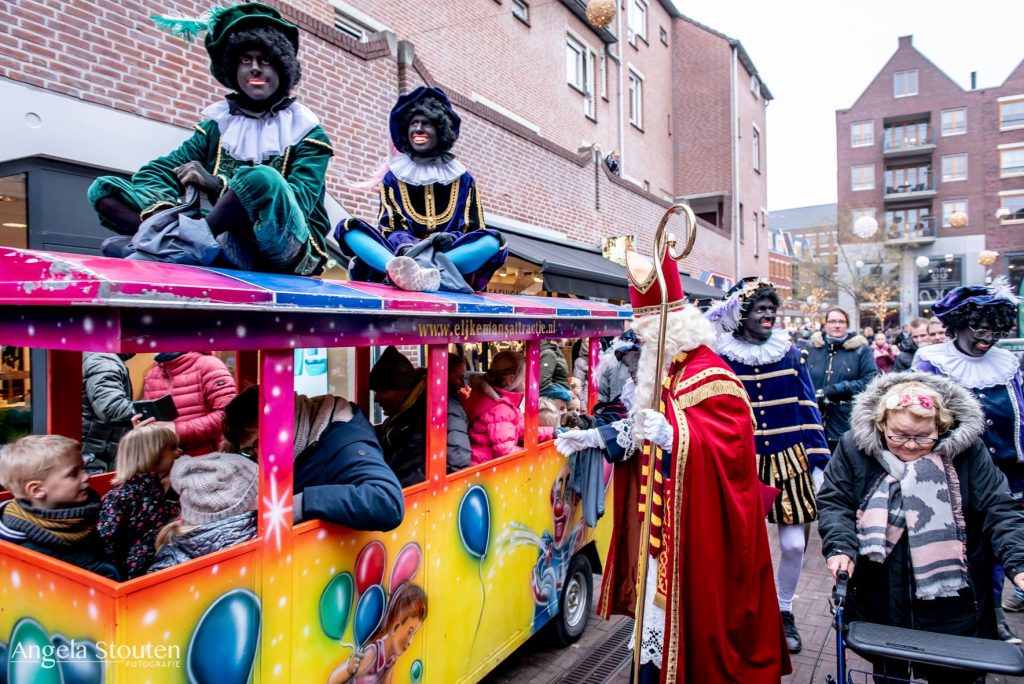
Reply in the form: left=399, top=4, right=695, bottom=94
left=328, top=581, right=427, bottom=684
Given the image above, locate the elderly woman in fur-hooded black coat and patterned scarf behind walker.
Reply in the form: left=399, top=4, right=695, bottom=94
left=817, top=373, right=1024, bottom=683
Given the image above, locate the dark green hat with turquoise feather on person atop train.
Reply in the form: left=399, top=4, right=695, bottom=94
left=153, top=2, right=299, bottom=80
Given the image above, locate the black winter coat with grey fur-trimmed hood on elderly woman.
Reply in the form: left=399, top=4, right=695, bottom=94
left=817, top=373, right=1024, bottom=638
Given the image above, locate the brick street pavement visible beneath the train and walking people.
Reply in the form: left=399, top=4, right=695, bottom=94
left=484, top=525, right=1024, bottom=684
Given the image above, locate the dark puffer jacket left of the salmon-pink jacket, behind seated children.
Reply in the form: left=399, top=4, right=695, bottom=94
left=82, top=353, right=133, bottom=470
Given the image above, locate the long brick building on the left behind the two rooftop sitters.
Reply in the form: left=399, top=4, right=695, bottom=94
left=0, top=0, right=771, bottom=293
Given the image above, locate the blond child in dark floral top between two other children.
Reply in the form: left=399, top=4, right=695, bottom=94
left=96, top=425, right=181, bottom=580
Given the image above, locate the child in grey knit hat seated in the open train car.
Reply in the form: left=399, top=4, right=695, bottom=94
left=150, top=452, right=259, bottom=572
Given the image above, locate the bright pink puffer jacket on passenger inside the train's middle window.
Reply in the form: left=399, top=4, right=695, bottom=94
left=466, top=376, right=523, bottom=466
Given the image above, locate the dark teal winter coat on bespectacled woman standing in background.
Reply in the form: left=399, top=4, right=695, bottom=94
left=807, top=332, right=879, bottom=442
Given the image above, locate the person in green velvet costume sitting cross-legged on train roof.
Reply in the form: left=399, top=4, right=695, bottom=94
left=89, top=2, right=333, bottom=275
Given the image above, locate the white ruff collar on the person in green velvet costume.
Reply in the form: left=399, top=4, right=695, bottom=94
left=203, top=99, right=319, bottom=164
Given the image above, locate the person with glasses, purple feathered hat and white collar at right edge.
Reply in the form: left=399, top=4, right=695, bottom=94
left=913, top=277, right=1024, bottom=643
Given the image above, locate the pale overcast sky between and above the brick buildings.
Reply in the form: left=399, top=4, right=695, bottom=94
left=674, top=0, right=1024, bottom=210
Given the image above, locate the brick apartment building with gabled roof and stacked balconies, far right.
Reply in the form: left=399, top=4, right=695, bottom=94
left=836, top=36, right=1024, bottom=323
